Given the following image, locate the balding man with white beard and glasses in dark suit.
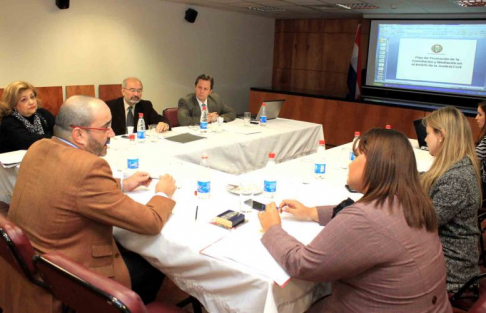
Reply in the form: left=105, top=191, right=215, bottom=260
left=106, top=77, right=170, bottom=135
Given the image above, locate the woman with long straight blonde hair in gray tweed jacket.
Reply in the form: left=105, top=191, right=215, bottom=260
left=421, top=107, right=481, bottom=292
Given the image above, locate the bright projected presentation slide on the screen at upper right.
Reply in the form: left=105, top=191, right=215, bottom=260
left=366, top=20, right=486, bottom=97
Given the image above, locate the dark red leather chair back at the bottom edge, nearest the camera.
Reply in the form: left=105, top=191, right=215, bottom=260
left=34, top=253, right=184, bottom=313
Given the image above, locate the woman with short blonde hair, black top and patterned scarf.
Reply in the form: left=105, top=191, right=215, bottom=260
left=0, top=81, right=55, bottom=152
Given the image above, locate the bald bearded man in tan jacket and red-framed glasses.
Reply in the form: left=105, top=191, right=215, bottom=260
left=0, top=96, right=175, bottom=313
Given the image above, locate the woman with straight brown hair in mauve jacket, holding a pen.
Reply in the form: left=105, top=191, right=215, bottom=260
left=258, top=128, right=452, bottom=312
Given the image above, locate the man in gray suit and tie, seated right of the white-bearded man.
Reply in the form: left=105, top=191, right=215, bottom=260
left=177, top=74, right=236, bottom=126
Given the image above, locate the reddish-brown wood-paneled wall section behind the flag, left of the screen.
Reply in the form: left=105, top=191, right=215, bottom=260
left=272, top=19, right=369, bottom=96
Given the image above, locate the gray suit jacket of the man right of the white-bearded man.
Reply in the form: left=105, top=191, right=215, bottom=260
left=177, top=93, right=236, bottom=126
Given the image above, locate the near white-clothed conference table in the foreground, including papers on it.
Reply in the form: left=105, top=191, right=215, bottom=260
left=114, top=122, right=431, bottom=312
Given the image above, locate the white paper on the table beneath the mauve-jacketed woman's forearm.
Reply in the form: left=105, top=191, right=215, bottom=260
left=201, top=217, right=324, bottom=287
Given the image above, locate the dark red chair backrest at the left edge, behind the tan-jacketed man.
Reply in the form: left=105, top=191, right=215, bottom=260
left=0, top=216, right=46, bottom=288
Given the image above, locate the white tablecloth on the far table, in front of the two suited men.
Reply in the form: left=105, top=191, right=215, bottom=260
left=106, top=118, right=324, bottom=174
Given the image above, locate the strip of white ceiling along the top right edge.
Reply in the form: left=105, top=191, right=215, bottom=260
left=164, top=0, right=486, bottom=19
